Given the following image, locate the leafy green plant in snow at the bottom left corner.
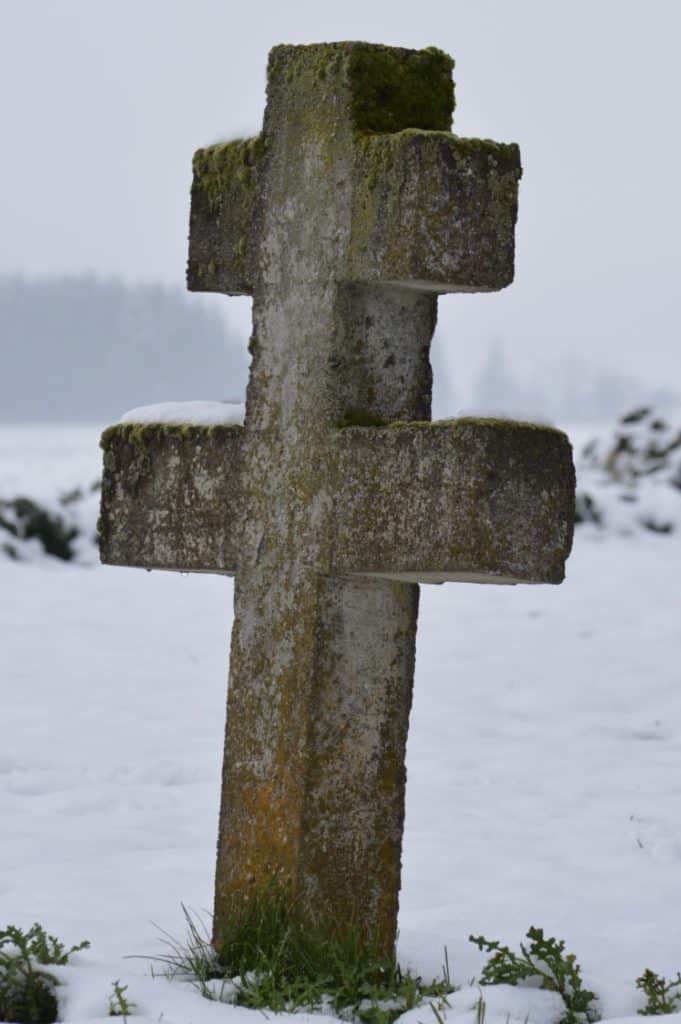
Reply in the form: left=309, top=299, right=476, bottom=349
left=0, top=924, right=90, bottom=1024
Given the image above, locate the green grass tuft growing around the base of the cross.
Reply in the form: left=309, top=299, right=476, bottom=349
left=137, top=889, right=454, bottom=1024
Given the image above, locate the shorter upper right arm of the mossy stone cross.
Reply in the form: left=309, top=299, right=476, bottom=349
left=348, top=129, right=522, bottom=292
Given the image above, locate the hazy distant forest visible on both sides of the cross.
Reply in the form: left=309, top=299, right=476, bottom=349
left=0, top=274, right=679, bottom=425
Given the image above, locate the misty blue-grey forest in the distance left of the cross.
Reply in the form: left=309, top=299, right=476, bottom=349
left=0, top=275, right=248, bottom=424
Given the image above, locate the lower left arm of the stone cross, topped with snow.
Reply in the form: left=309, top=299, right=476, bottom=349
left=97, top=424, right=243, bottom=575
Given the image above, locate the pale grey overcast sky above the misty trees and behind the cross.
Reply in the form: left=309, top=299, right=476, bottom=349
left=0, top=0, right=681, bottom=397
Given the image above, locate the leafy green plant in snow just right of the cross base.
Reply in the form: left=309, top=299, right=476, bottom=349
left=470, top=928, right=599, bottom=1024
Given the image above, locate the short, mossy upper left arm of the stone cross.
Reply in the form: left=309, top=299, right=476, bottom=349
left=186, top=135, right=263, bottom=295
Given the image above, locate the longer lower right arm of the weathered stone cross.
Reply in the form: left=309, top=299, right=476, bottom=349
left=333, top=419, right=574, bottom=584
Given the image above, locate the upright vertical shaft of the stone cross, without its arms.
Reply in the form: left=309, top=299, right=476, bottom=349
left=216, top=51, right=436, bottom=948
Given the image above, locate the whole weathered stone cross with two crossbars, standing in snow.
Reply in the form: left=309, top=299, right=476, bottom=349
left=100, top=43, right=573, bottom=949
